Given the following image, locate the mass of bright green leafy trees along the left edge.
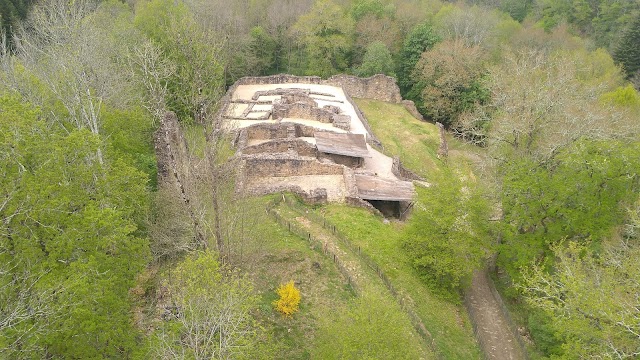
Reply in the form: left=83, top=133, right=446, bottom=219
left=0, top=95, right=149, bottom=358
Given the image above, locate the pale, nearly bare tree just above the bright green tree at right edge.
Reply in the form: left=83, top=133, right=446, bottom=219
left=480, top=51, right=638, bottom=161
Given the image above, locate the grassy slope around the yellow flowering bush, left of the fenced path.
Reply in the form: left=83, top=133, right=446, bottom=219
left=220, top=196, right=355, bottom=359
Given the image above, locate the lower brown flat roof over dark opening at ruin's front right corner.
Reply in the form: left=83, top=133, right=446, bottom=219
left=356, top=174, right=416, bottom=201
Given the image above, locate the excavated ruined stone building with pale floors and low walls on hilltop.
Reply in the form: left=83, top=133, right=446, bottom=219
left=217, top=75, right=415, bottom=217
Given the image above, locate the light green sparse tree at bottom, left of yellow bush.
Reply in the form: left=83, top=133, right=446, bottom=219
left=154, top=251, right=273, bottom=359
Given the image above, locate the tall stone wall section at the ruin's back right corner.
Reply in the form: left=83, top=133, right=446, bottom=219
left=324, top=74, right=402, bottom=103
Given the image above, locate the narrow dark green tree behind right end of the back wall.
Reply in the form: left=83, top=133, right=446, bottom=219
left=397, top=23, right=440, bottom=94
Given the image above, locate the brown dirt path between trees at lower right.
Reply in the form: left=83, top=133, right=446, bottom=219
left=467, top=271, right=525, bottom=360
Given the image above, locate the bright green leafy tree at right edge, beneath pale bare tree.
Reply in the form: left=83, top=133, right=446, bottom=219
left=498, top=141, right=640, bottom=280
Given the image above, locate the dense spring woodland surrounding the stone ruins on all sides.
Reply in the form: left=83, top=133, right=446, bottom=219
left=0, top=0, right=640, bottom=359
